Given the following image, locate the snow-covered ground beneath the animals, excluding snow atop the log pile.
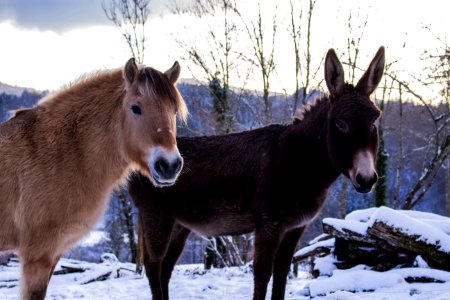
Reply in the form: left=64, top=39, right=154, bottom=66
left=0, top=259, right=450, bottom=300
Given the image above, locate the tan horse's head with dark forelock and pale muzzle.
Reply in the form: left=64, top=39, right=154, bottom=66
left=123, top=58, right=187, bottom=186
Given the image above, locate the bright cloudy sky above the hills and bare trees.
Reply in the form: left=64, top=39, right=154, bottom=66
left=0, top=0, right=450, bottom=97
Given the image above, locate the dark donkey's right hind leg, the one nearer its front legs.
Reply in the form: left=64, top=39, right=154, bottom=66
left=161, top=224, right=191, bottom=300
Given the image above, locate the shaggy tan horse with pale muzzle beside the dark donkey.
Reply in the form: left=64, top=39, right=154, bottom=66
left=0, top=59, right=187, bottom=299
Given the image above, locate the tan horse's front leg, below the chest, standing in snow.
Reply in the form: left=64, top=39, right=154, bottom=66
left=21, top=255, right=58, bottom=300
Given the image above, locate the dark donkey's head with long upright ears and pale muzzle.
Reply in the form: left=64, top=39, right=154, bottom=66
left=325, top=47, right=384, bottom=193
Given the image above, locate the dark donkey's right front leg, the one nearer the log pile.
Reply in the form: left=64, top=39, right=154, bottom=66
left=272, top=227, right=305, bottom=300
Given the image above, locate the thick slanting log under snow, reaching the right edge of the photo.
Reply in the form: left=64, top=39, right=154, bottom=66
left=367, top=221, right=450, bottom=271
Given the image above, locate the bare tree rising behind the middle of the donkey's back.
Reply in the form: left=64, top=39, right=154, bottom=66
left=169, top=0, right=242, bottom=133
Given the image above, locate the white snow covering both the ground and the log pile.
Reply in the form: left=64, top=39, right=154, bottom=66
left=0, top=207, right=450, bottom=300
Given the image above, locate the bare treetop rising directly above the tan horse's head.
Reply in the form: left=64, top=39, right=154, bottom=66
left=102, top=0, right=151, bottom=63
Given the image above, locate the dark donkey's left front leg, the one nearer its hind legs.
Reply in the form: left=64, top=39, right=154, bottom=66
left=253, top=225, right=282, bottom=300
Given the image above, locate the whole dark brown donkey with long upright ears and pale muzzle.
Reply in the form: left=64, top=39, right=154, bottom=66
left=128, top=47, right=385, bottom=300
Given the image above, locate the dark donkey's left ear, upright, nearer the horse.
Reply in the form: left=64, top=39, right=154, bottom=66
left=325, top=49, right=345, bottom=96
